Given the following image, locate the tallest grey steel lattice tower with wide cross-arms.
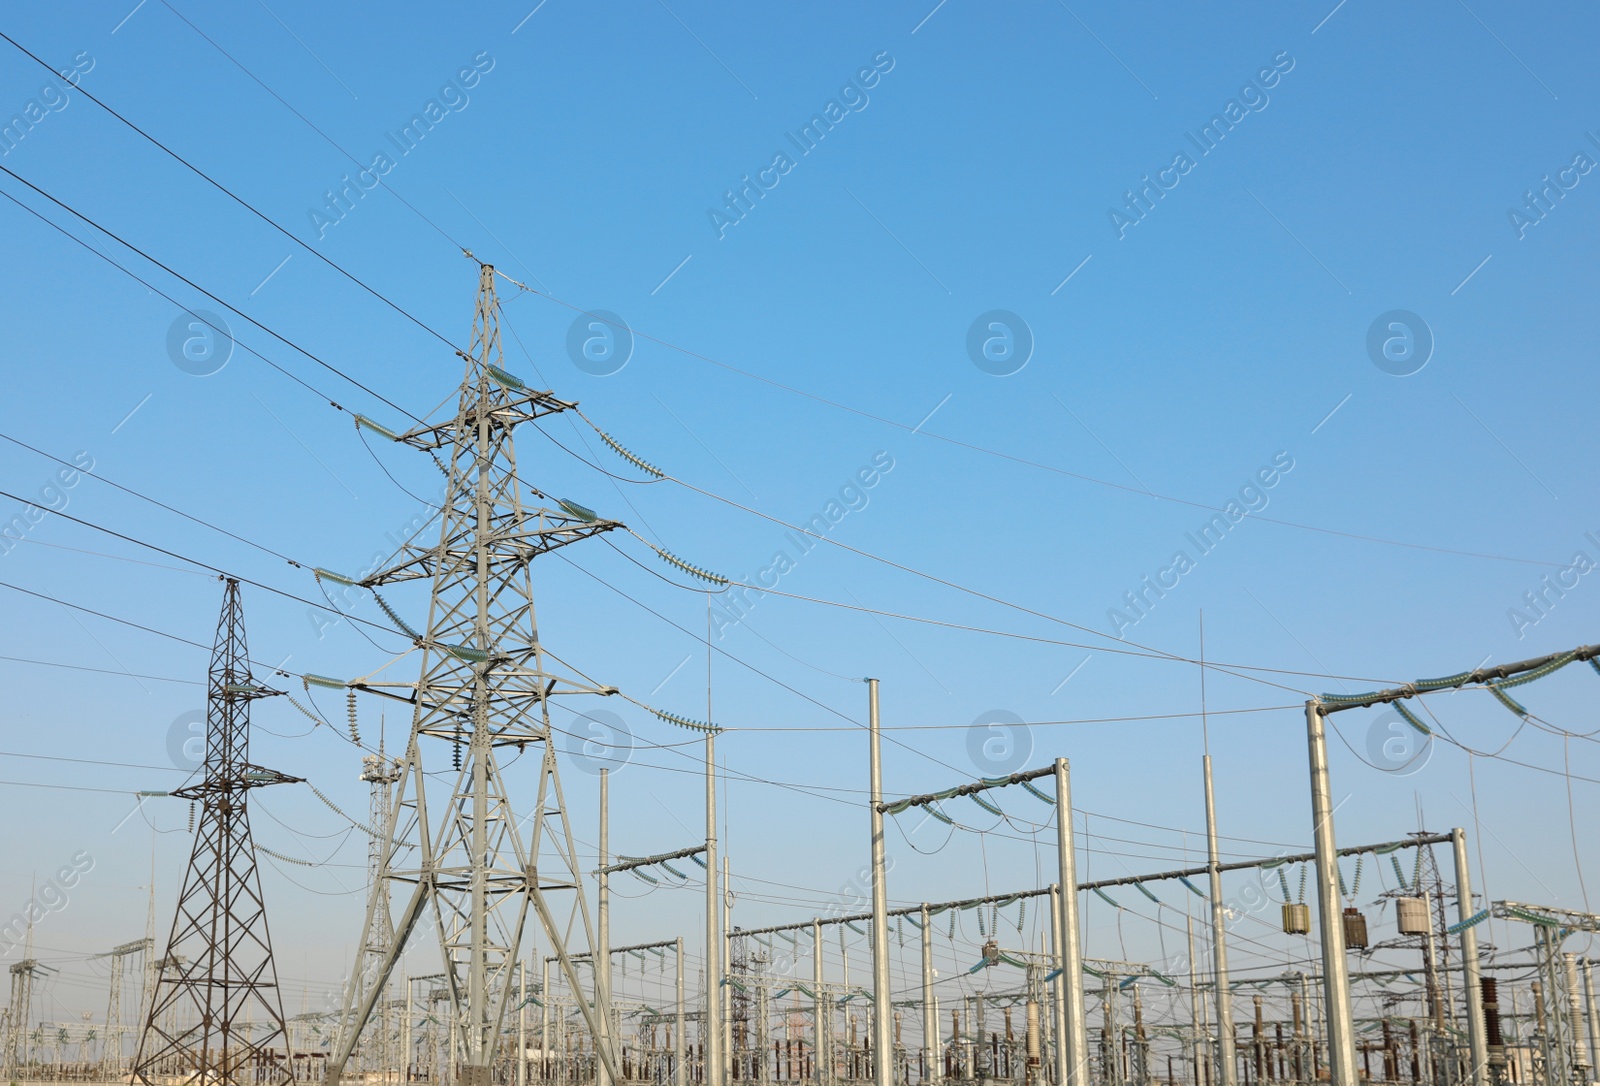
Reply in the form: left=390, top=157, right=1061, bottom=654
left=328, top=264, right=619, bottom=1086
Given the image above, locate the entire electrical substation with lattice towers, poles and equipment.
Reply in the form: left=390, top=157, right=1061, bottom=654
left=3, top=264, right=1600, bottom=1086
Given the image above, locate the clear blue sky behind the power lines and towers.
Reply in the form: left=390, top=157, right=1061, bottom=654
left=0, top=0, right=1600, bottom=1036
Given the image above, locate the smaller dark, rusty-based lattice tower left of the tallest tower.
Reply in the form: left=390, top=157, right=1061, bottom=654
left=133, top=579, right=299, bottom=1086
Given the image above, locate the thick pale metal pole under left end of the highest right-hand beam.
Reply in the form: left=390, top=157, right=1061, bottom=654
left=1306, top=697, right=1360, bottom=1086
